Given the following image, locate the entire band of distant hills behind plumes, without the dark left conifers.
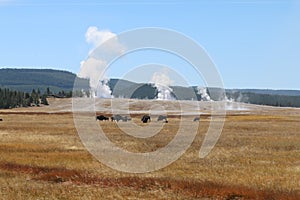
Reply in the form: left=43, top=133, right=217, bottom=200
left=0, top=69, right=300, bottom=107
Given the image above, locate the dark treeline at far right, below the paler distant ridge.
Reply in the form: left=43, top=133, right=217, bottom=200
left=226, top=92, right=300, bottom=107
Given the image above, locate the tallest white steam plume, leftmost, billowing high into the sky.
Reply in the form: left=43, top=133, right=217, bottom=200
left=78, top=26, right=125, bottom=98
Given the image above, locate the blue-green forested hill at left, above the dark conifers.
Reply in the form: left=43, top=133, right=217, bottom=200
left=0, top=69, right=88, bottom=92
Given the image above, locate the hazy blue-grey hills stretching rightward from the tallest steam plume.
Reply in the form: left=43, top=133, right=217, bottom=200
left=108, top=79, right=300, bottom=107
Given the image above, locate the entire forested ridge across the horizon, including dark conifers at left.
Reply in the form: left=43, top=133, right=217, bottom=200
left=0, top=69, right=300, bottom=108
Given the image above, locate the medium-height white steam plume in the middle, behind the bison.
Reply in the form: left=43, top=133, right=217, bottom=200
left=151, top=70, right=175, bottom=100
